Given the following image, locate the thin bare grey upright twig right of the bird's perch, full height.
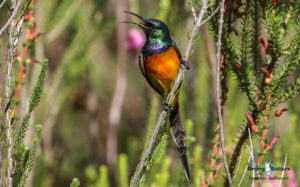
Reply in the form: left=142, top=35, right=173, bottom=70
left=216, top=0, right=232, bottom=186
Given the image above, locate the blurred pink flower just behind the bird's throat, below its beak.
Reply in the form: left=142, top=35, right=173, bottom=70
left=126, top=28, right=146, bottom=52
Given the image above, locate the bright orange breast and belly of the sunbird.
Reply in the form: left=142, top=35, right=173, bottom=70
left=144, top=47, right=180, bottom=96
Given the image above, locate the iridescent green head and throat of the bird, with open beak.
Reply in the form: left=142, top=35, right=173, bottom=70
left=124, top=11, right=173, bottom=54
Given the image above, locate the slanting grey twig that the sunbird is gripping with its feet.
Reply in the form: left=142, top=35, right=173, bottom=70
left=130, top=0, right=207, bottom=187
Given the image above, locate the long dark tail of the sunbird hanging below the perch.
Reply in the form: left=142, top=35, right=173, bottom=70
left=169, top=103, right=191, bottom=181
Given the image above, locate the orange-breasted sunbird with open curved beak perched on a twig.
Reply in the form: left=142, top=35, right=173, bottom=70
left=123, top=11, right=191, bottom=181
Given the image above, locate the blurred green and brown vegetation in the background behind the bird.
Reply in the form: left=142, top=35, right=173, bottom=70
left=0, top=0, right=300, bottom=187
